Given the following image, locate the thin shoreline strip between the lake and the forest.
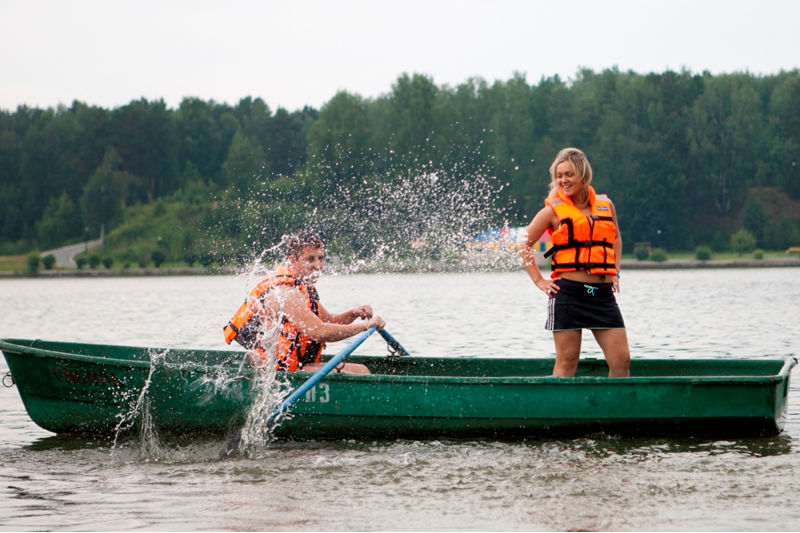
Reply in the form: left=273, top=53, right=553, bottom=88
left=0, top=257, right=800, bottom=279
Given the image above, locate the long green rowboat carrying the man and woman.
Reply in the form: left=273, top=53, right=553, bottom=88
left=0, top=339, right=797, bottom=439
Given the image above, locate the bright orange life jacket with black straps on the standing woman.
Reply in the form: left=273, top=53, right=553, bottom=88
left=544, top=187, right=617, bottom=278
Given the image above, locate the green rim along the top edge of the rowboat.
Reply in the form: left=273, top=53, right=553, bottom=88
left=0, top=339, right=798, bottom=386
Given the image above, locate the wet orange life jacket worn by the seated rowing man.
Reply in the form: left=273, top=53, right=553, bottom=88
left=222, top=266, right=325, bottom=372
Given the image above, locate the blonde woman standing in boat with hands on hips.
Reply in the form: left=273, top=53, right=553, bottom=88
left=521, top=148, right=630, bottom=377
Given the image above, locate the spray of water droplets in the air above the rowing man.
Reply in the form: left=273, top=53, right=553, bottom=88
left=199, top=148, right=510, bottom=272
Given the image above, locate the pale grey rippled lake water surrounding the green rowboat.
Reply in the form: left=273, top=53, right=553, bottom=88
left=0, top=268, right=800, bottom=531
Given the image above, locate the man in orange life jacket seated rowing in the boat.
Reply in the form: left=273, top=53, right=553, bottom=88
left=223, top=231, right=386, bottom=374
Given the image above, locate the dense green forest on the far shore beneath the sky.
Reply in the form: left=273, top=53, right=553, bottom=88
left=0, top=69, right=800, bottom=265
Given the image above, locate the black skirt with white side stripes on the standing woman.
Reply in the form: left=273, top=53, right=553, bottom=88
left=544, top=279, right=625, bottom=331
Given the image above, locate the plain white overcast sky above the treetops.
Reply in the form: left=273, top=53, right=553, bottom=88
left=0, top=0, right=800, bottom=111
